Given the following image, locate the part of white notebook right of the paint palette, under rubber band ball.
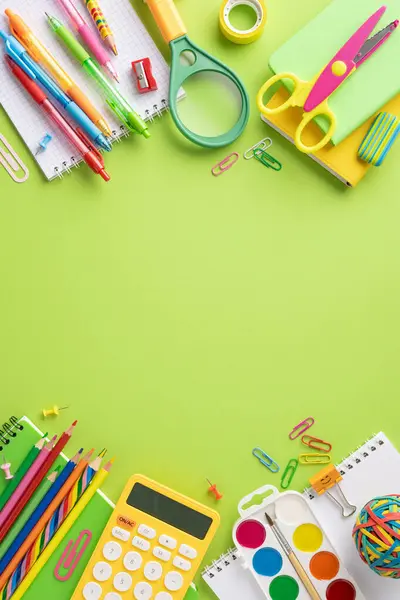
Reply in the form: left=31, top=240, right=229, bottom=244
left=306, top=433, right=400, bottom=600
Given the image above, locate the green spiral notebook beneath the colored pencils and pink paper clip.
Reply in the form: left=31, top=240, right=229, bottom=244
left=0, top=417, right=197, bottom=600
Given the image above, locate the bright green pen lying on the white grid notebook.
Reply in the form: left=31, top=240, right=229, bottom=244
left=46, top=13, right=150, bottom=138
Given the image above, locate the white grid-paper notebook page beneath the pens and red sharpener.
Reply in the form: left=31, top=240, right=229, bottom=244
left=0, top=0, right=183, bottom=179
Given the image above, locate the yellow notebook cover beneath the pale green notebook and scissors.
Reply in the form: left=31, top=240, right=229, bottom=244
left=262, top=86, right=400, bottom=187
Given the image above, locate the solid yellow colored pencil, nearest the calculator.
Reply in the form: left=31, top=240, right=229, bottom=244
left=8, top=460, right=114, bottom=600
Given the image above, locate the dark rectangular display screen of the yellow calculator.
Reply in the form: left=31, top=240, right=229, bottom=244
left=126, top=483, right=212, bottom=540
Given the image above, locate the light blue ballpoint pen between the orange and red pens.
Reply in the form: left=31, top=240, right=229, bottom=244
left=0, top=30, right=112, bottom=152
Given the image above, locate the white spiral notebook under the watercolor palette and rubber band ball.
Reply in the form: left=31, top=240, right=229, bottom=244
left=203, top=433, right=400, bottom=600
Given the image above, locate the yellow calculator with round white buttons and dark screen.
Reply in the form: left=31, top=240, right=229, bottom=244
left=71, top=475, right=220, bottom=600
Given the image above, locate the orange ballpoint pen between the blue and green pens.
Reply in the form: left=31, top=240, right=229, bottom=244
left=5, top=8, right=112, bottom=136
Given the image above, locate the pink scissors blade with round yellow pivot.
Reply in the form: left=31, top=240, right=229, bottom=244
left=304, top=6, right=387, bottom=112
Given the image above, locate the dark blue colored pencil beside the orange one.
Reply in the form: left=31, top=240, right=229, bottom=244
left=0, top=448, right=83, bottom=574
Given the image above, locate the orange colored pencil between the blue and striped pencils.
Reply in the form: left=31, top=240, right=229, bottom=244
left=0, top=442, right=87, bottom=589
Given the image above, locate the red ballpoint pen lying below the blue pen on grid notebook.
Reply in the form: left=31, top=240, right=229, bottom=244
left=6, top=56, right=110, bottom=181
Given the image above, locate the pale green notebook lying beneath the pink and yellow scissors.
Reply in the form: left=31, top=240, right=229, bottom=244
left=269, top=0, right=400, bottom=144
